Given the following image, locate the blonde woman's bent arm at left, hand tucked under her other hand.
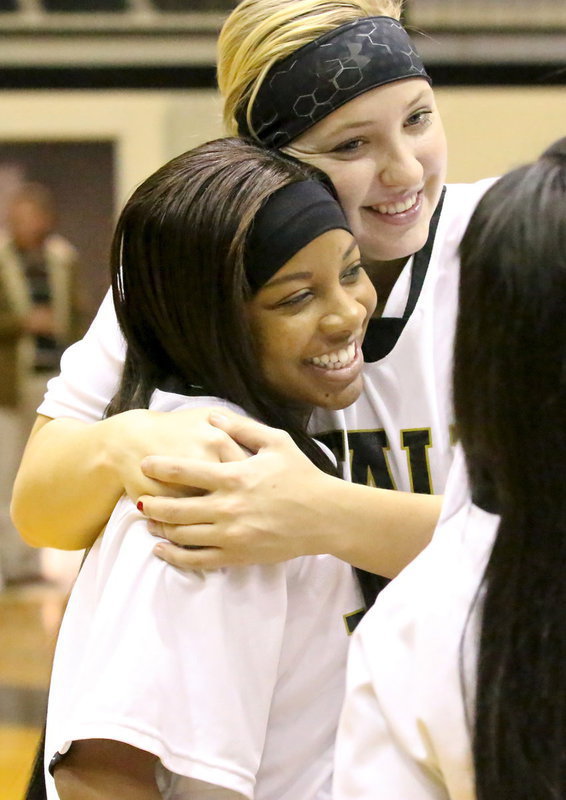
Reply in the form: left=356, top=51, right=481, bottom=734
left=11, top=408, right=244, bottom=550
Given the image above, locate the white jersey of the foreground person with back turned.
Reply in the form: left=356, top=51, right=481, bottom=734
left=333, top=450, right=499, bottom=800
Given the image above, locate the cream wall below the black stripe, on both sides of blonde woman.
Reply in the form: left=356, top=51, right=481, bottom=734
left=0, top=86, right=566, bottom=200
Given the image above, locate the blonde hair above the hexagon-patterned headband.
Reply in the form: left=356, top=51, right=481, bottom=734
left=217, top=0, right=403, bottom=135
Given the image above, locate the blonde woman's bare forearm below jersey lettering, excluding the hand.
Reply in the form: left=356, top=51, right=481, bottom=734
left=312, top=472, right=442, bottom=578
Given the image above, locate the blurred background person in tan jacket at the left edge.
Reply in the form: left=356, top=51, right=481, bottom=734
left=0, top=183, right=83, bottom=583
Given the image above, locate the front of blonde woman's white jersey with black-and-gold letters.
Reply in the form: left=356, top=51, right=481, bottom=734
left=311, top=179, right=493, bottom=494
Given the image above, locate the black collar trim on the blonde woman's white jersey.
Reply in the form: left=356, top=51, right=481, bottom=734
left=362, top=186, right=446, bottom=363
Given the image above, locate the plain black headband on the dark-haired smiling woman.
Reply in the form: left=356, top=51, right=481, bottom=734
left=245, top=180, right=351, bottom=292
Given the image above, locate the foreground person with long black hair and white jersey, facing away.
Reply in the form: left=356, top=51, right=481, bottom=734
left=334, top=138, right=566, bottom=800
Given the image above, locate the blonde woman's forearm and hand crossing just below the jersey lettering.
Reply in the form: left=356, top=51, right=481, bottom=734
left=142, top=415, right=442, bottom=577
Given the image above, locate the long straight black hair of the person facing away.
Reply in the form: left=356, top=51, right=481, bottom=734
left=454, top=138, right=566, bottom=800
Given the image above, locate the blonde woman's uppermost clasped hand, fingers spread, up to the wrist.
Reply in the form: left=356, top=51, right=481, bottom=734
left=136, top=415, right=341, bottom=568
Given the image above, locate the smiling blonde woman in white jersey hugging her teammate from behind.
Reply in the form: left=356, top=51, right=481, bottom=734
left=13, top=0, right=494, bottom=588
